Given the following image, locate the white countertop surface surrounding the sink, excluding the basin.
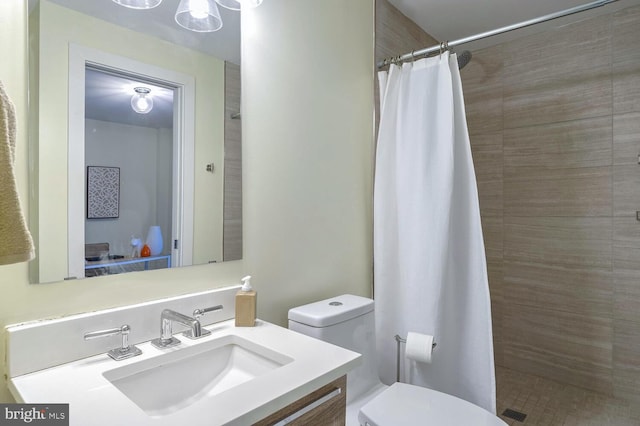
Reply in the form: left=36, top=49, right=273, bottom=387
left=9, top=320, right=360, bottom=426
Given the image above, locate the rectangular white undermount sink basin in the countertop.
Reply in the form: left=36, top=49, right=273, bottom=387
left=103, top=335, right=293, bottom=417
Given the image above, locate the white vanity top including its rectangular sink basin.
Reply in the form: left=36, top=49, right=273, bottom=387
left=8, top=320, right=361, bottom=426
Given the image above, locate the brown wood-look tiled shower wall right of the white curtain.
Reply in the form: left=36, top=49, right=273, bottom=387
left=461, top=7, right=640, bottom=400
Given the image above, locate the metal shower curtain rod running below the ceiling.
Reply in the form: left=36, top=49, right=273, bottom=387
left=378, top=0, right=618, bottom=69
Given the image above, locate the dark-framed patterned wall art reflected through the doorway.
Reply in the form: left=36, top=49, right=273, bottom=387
left=87, top=166, right=120, bottom=219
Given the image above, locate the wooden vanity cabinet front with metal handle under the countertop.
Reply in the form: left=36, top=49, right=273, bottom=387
left=253, top=376, right=347, bottom=426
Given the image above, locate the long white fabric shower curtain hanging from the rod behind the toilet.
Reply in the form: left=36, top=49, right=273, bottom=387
left=374, top=52, right=496, bottom=413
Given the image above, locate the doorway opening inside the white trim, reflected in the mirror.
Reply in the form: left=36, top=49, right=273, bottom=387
left=85, top=65, right=174, bottom=277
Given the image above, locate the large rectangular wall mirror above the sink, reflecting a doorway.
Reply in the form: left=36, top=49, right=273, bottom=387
left=29, top=0, right=242, bottom=283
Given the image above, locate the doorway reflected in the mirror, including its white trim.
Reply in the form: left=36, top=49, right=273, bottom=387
left=67, top=45, right=195, bottom=278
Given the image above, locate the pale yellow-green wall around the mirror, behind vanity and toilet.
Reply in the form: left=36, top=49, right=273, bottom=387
left=0, top=0, right=373, bottom=401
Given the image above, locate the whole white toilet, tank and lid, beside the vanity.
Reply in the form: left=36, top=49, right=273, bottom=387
left=289, top=294, right=506, bottom=426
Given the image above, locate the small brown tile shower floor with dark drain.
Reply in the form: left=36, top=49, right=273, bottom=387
left=496, top=367, right=640, bottom=426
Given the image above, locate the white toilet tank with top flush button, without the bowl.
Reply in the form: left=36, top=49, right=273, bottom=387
left=289, top=294, right=380, bottom=403
